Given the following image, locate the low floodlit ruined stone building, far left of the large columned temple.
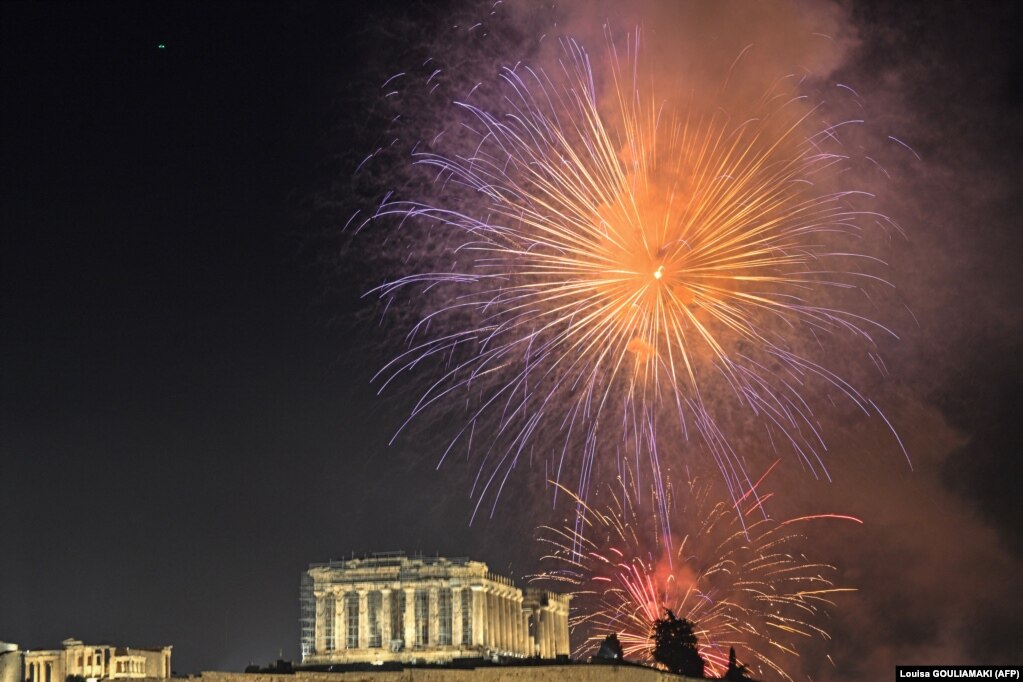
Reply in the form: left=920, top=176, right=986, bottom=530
left=21, top=639, right=171, bottom=682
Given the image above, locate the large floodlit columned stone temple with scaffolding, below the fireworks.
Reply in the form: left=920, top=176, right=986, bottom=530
left=301, top=553, right=571, bottom=666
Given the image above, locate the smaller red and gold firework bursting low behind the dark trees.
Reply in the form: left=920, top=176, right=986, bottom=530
left=532, top=475, right=858, bottom=680
